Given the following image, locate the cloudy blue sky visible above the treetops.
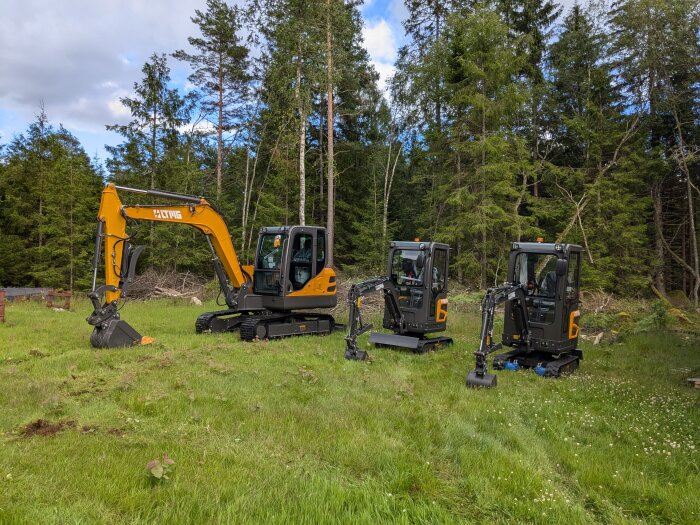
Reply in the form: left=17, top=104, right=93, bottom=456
left=0, top=0, right=574, bottom=164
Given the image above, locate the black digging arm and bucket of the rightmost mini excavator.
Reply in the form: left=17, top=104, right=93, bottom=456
left=467, top=283, right=531, bottom=386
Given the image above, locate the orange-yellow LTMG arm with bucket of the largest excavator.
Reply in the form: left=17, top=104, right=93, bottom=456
left=87, top=183, right=252, bottom=348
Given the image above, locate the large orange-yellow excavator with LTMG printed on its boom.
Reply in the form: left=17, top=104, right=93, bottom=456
left=87, top=183, right=337, bottom=348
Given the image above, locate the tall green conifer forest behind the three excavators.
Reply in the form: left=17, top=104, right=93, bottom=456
left=0, top=0, right=700, bottom=305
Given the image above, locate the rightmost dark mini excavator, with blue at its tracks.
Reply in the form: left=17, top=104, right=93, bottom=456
left=467, top=241, right=583, bottom=387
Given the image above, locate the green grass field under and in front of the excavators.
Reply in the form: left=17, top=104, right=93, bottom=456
left=0, top=300, right=700, bottom=524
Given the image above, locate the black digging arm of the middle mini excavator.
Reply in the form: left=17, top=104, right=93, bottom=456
left=345, top=277, right=406, bottom=361
